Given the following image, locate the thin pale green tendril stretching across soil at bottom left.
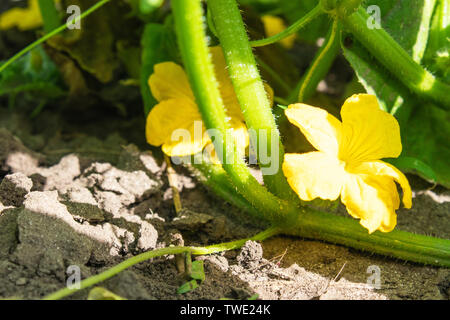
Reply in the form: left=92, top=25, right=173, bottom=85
left=43, top=228, right=279, bottom=300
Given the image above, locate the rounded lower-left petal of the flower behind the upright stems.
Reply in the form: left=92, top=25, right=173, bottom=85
left=145, top=99, right=204, bottom=156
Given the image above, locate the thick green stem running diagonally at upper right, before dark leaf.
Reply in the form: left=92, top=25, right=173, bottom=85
left=342, top=7, right=450, bottom=110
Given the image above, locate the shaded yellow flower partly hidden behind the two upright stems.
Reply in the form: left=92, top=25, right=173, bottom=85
left=145, top=47, right=273, bottom=160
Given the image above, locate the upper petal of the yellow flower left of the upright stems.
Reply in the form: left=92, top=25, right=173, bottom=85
left=148, top=62, right=195, bottom=102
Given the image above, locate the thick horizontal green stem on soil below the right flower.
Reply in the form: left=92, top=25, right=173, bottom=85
left=282, top=210, right=450, bottom=267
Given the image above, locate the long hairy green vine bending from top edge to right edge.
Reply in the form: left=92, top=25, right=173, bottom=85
left=172, top=0, right=450, bottom=265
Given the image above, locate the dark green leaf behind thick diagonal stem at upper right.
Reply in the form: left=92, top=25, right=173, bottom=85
left=342, top=0, right=450, bottom=187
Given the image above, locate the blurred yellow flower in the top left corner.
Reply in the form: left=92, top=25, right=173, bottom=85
left=0, top=0, right=42, bottom=31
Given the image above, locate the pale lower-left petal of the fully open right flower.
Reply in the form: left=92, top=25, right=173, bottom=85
left=283, top=151, right=345, bottom=201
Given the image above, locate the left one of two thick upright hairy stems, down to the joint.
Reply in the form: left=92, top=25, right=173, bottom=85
left=172, top=0, right=295, bottom=224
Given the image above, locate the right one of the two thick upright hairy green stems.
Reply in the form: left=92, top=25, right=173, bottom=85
left=208, top=0, right=298, bottom=201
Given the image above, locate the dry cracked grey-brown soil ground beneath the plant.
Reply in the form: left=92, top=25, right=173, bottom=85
left=0, top=101, right=450, bottom=300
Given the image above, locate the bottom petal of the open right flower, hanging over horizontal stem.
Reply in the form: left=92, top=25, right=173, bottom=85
left=341, top=174, right=400, bottom=233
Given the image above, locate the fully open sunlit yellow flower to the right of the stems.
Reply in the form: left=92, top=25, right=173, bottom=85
left=283, top=94, right=412, bottom=233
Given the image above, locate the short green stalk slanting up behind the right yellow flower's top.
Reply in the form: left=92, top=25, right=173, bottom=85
left=290, top=19, right=340, bottom=102
